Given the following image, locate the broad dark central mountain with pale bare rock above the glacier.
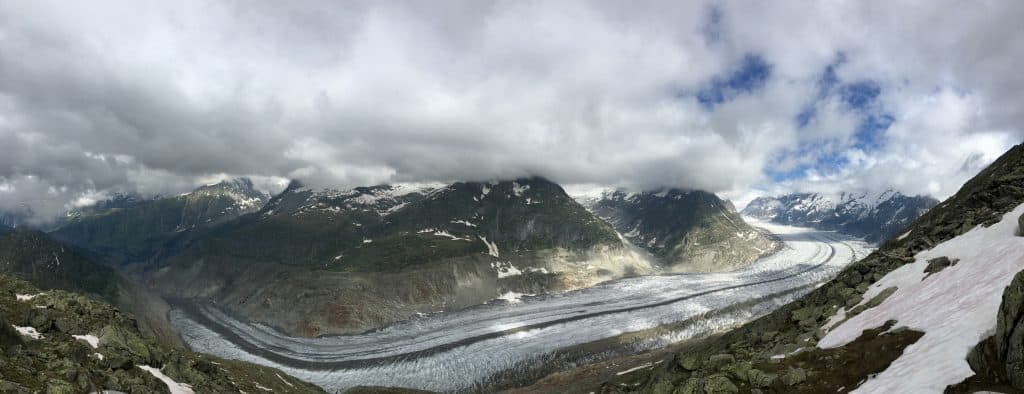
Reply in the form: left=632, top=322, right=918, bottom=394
left=152, top=178, right=652, bottom=336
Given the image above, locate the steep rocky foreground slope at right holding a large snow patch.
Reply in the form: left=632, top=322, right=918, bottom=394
left=600, top=145, right=1024, bottom=393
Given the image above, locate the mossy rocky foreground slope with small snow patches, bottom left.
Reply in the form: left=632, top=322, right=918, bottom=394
left=0, top=274, right=323, bottom=393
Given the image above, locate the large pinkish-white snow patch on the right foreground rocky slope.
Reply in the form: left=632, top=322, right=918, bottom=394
left=818, top=200, right=1024, bottom=393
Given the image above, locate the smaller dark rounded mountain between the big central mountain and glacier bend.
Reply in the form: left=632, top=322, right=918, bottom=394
left=586, top=189, right=776, bottom=272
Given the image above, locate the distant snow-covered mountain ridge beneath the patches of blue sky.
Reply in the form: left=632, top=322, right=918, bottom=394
left=742, top=190, right=938, bottom=243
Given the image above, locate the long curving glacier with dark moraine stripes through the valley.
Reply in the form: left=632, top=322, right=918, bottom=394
left=171, top=217, right=870, bottom=392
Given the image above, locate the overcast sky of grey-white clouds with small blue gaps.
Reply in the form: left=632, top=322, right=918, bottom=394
left=0, top=0, right=1024, bottom=216
